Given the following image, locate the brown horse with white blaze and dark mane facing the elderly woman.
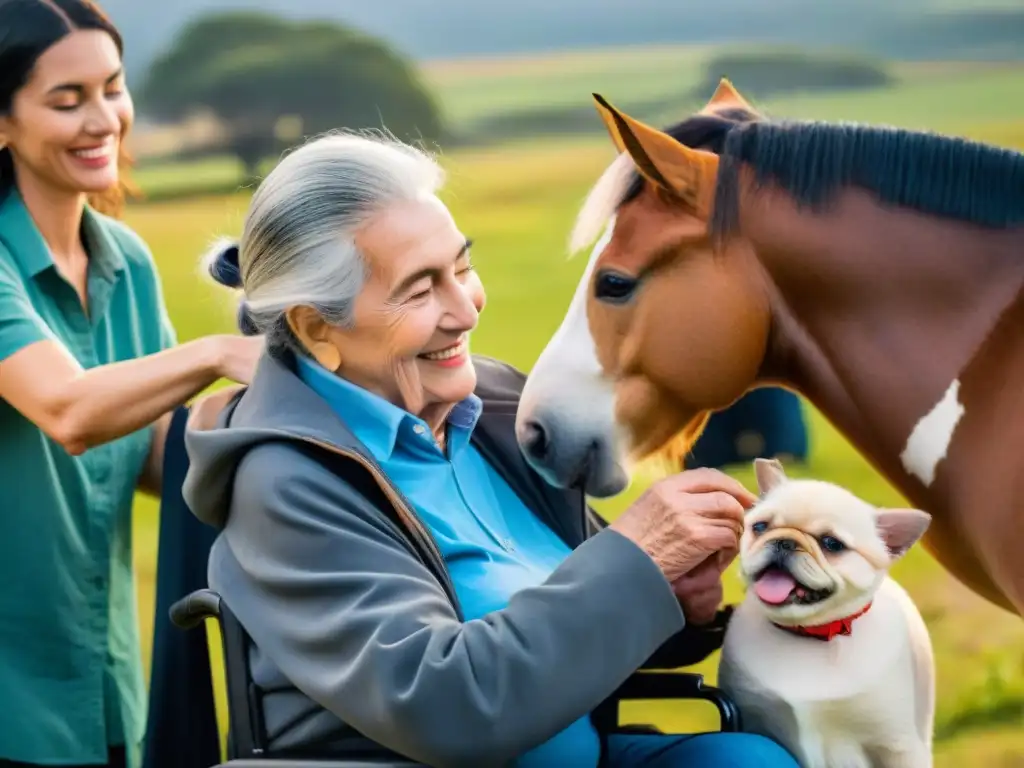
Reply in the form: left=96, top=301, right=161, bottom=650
left=517, top=81, right=1024, bottom=615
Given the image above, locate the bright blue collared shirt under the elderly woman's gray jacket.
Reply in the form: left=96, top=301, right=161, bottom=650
left=298, top=355, right=600, bottom=768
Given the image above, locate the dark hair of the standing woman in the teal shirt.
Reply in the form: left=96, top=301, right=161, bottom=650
left=0, top=0, right=137, bottom=215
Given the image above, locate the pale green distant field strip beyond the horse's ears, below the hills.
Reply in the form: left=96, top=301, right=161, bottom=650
left=424, top=46, right=1024, bottom=137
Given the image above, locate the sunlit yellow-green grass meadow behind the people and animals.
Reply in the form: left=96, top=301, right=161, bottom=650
left=126, top=48, right=1024, bottom=768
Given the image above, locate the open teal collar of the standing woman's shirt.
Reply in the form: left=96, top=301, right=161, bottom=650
left=0, top=187, right=125, bottom=282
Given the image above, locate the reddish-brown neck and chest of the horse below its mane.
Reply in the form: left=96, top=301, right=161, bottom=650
left=764, top=210, right=1024, bottom=615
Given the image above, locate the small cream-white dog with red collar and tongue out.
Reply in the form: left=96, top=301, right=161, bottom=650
left=719, top=459, right=935, bottom=768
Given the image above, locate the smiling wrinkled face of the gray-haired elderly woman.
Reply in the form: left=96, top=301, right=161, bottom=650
left=302, top=198, right=485, bottom=415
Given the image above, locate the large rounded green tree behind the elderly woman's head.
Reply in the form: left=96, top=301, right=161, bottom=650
left=140, top=12, right=442, bottom=174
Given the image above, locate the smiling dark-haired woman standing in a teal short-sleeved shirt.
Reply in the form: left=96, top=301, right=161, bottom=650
left=0, top=0, right=262, bottom=766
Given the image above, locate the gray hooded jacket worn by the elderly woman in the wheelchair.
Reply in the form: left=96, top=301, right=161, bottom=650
left=184, top=356, right=721, bottom=768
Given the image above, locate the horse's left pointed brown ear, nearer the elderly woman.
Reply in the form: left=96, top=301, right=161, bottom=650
left=594, top=93, right=718, bottom=218
